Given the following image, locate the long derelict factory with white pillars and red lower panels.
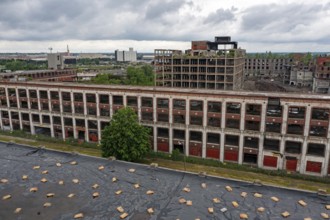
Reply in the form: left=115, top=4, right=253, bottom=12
left=0, top=82, right=330, bottom=176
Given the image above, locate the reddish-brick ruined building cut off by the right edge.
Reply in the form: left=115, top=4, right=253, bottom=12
left=313, top=56, right=330, bottom=94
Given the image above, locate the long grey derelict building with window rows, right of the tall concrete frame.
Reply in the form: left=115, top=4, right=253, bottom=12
left=245, top=57, right=291, bottom=79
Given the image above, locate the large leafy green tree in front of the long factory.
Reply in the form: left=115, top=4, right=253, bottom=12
left=101, top=107, right=150, bottom=161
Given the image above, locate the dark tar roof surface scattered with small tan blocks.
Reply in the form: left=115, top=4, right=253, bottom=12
left=0, top=143, right=330, bottom=220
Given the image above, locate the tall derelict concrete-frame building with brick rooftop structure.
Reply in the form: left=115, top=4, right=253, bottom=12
left=154, top=37, right=245, bottom=90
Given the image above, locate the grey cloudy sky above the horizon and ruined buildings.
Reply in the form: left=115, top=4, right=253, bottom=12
left=0, top=0, right=330, bottom=53
